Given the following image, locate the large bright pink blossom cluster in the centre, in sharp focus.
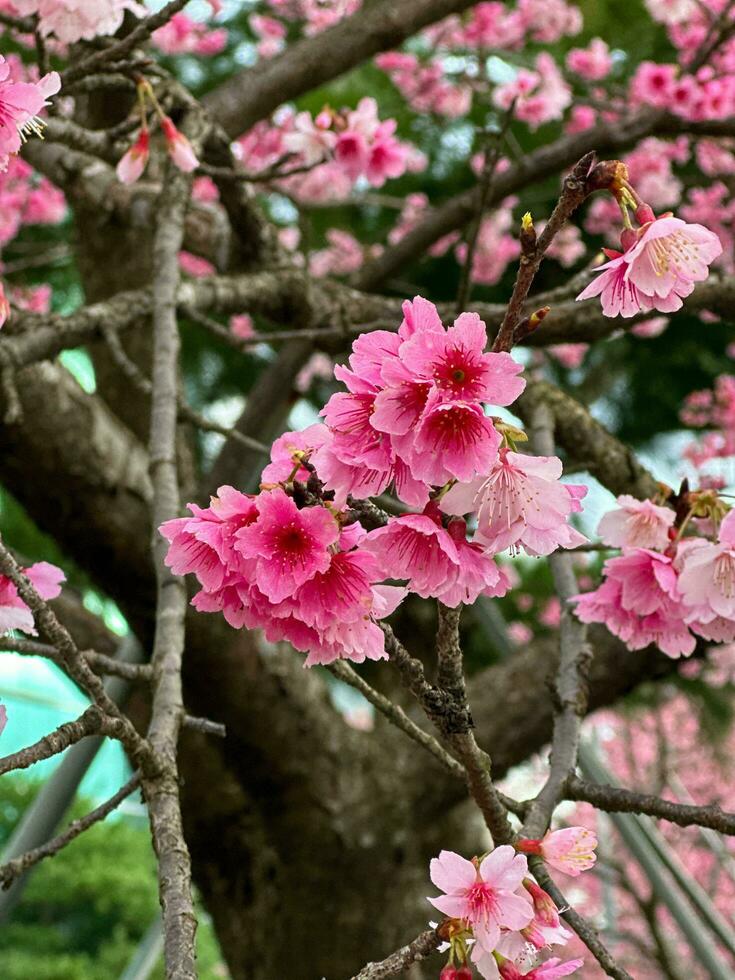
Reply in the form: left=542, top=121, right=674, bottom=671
left=161, top=297, right=586, bottom=666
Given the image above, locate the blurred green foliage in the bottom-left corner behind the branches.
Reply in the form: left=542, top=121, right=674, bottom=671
left=0, top=776, right=227, bottom=980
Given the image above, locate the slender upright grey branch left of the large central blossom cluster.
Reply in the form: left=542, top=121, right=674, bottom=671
left=143, top=151, right=197, bottom=980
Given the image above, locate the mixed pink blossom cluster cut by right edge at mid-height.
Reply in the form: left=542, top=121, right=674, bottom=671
left=573, top=490, right=735, bottom=657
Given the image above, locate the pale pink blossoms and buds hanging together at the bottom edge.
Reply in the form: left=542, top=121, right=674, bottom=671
left=429, top=827, right=597, bottom=980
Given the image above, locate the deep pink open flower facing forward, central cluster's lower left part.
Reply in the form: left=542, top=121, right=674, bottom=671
left=236, top=488, right=339, bottom=602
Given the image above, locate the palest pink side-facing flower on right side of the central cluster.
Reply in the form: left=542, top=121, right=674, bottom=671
left=440, top=448, right=587, bottom=555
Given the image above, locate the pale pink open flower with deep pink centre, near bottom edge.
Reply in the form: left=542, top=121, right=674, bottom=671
left=429, top=844, right=533, bottom=952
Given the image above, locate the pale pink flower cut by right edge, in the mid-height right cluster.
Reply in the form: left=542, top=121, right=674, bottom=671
left=677, top=510, right=735, bottom=622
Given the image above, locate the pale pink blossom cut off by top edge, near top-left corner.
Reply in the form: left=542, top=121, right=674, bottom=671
left=12, top=0, right=146, bottom=44
